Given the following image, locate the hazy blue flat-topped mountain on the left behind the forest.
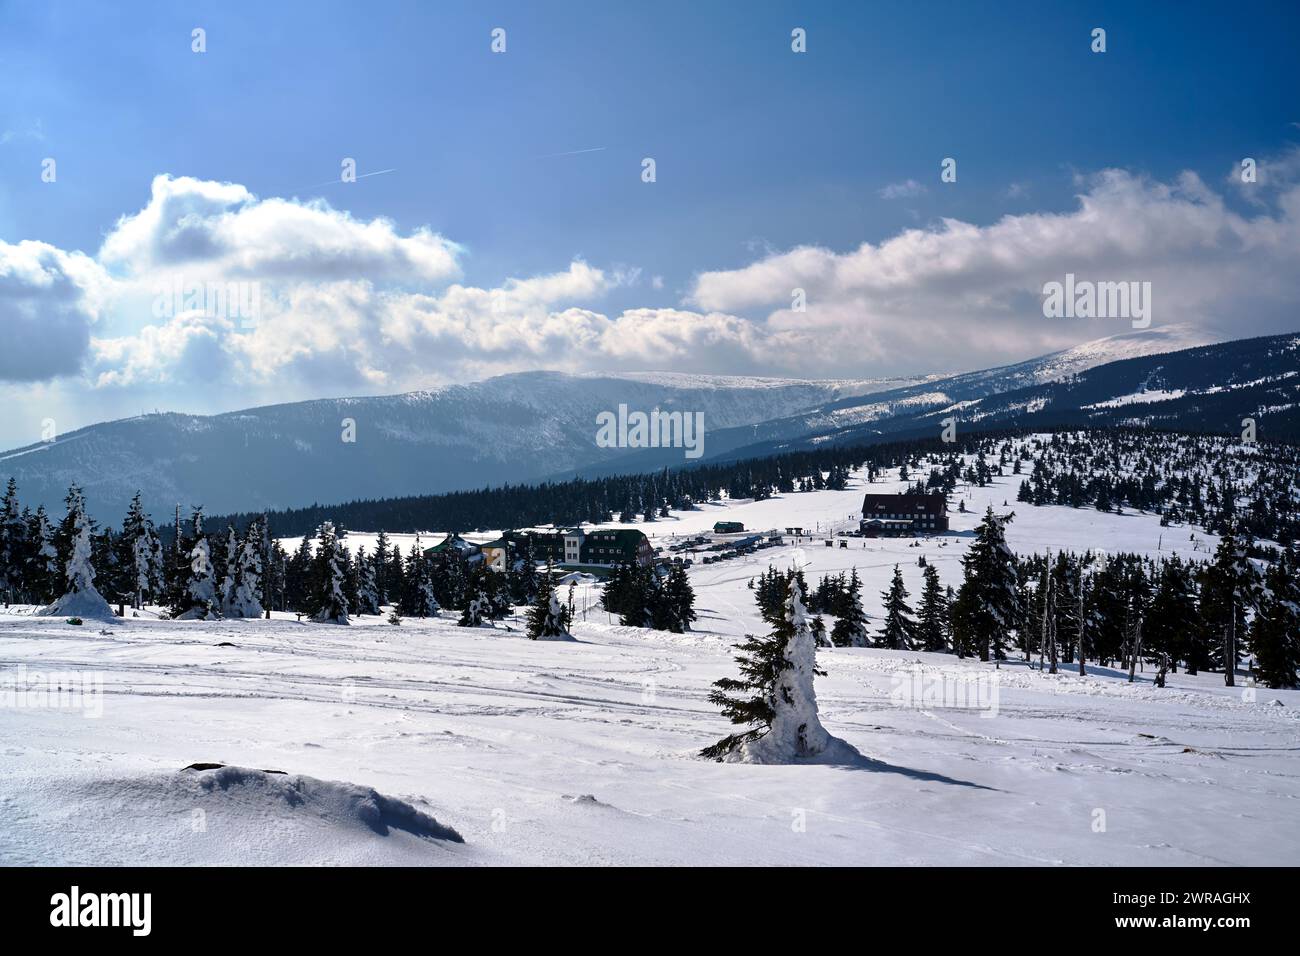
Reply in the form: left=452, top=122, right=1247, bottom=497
left=0, top=372, right=917, bottom=522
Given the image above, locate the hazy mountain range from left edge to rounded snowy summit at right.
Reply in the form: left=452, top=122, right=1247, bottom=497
left=0, top=326, right=1237, bottom=522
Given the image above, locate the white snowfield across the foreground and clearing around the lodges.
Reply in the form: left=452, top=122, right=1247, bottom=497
left=0, top=463, right=1300, bottom=865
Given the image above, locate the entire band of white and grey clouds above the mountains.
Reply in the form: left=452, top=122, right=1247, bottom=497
left=0, top=156, right=1300, bottom=398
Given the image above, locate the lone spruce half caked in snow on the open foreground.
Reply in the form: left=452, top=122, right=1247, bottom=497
left=701, top=576, right=859, bottom=763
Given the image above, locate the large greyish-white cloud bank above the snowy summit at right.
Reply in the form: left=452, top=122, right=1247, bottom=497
left=689, top=164, right=1300, bottom=367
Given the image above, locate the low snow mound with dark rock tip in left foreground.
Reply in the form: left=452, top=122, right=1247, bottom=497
left=24, top=763, right=465, bottom=866
